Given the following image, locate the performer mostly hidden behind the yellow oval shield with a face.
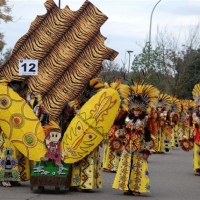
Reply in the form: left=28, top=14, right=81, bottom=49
left=70, top=77, right=105, bottom=192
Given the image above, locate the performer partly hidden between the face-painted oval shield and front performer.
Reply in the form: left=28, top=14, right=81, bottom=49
left=103, top=80, right=129, bottom=172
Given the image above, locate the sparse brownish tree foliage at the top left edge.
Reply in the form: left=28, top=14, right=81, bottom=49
left=0, top=0, right=13, bottom=50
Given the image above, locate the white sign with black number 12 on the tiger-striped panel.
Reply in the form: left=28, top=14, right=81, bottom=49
left=19, top=59, right=38, bottom=76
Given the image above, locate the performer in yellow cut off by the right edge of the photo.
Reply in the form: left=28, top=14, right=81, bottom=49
left=192, top=84, right=200, bottom=176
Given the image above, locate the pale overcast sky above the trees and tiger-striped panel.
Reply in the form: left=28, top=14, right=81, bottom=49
left=0, top=0, right=200, bottom=67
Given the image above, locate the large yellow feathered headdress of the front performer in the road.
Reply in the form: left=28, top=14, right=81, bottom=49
left=128, top=83, right=159, bottom=111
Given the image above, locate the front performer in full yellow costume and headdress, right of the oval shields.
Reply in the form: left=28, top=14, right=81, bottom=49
left=112, top=83, right=158, bottom=196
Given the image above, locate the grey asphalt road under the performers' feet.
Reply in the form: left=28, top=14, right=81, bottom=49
left=0, top=148, right=200, bottom=200
